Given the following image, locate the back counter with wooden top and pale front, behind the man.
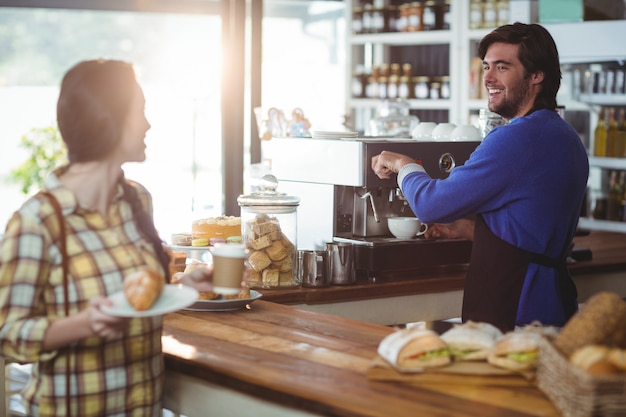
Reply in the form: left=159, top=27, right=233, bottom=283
left=260, top=231, right=626, bottom=325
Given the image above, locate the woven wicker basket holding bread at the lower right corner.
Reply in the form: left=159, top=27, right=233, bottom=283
left=537, top=338, right=626, bottom=417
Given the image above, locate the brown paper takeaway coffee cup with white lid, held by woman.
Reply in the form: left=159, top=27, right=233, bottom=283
left=212, top=244, right=246, bottom=295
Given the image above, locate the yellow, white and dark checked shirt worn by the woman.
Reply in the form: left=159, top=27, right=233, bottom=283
left=0, top=173, right=163, bottom=417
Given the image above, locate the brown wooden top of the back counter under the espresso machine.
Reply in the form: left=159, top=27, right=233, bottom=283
left=259, top=231, right=626, bottom=304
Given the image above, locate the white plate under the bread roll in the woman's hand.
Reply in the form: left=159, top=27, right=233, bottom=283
left=100, top=284, right=199, bottom=317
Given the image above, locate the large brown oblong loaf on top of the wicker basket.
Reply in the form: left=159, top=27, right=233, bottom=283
left=554, top=292, right=626, bottom=357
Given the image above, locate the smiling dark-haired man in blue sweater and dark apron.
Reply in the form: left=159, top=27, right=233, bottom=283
left=372, top=23, right=589, bottom=330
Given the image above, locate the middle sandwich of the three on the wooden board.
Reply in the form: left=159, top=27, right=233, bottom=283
left=441, top=321, right=502, bottom=361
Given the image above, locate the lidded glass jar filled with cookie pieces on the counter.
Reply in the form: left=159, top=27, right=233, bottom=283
left=237, top=174, right=300, bottom=288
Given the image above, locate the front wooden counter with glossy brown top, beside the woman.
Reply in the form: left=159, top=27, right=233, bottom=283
left=163, top=300, right=559, bottom=417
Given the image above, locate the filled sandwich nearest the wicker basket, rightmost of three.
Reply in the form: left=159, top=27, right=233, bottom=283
left=487, top=331, right=542, bottom=372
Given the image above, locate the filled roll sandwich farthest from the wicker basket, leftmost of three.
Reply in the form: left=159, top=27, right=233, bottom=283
left=378, top=329, right=450, bottom=371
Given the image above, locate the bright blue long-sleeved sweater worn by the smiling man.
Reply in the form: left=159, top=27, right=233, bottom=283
left=398, top=110, right=589, bottom=325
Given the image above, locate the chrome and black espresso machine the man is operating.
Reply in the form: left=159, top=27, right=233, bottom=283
left=263, top=138, right=480, bottom=281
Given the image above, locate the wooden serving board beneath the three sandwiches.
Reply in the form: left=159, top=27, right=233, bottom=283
left=367, top=356, right=534, bottom=387
